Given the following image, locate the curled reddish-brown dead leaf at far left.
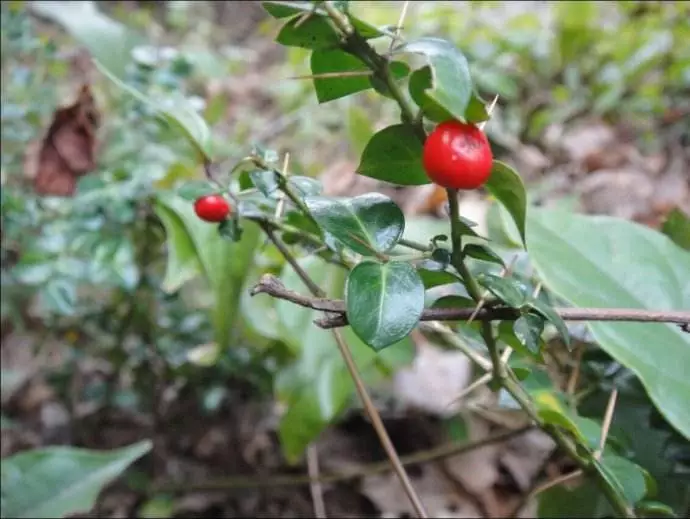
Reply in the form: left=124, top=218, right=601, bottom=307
left=25, top=83, right=100, bottom=196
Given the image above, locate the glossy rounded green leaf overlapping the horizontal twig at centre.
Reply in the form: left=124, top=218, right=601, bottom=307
left=345, top=261, right=424, bottom=351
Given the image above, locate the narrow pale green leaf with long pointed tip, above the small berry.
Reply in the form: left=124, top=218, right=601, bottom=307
left=94, top=61, right=213, bottom=161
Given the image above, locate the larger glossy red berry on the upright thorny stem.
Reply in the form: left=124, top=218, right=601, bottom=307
left=422, top=121, right=493, bottom=189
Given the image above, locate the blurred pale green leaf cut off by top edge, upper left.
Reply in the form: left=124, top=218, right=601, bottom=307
left=28, top=1, right=142, bottom=77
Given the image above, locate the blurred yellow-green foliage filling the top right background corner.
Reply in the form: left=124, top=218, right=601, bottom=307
left=355, top=1, right=690, bottom=148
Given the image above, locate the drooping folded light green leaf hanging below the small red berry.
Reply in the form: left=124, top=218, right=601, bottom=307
left=154, top=192, right=259, bottom=351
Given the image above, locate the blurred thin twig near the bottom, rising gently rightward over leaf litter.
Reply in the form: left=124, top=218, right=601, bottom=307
left=155, top=425, right=534, bottom=492
